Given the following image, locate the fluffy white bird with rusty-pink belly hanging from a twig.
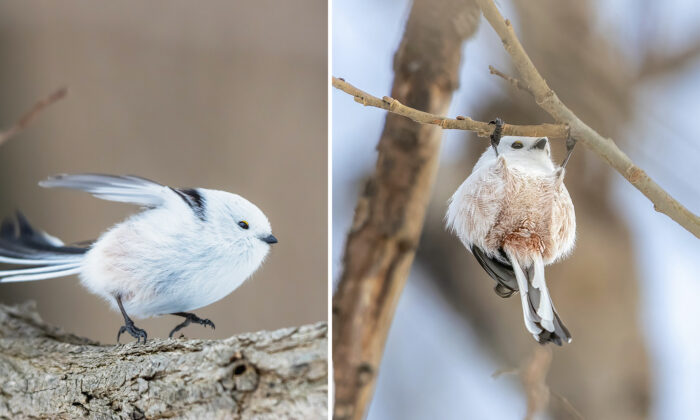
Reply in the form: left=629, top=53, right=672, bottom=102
left=446, top=119, right=576, bottom=345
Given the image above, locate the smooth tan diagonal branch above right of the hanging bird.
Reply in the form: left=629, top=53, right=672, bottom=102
left=476, top=0, right=700, bottom=238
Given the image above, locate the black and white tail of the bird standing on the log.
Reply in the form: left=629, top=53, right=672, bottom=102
left=0, top=212, right=89, bottom=283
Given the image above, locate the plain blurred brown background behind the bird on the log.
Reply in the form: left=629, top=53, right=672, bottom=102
left=0, top=0, right=327, bottom=343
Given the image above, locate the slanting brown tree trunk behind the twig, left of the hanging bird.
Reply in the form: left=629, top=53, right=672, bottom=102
left=333, top=0, right=479, bottom=420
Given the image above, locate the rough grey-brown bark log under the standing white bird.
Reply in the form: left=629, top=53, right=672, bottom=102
left=0, top=304, right=328, bottom=419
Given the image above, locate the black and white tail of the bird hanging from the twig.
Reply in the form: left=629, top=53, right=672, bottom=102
left=506, top=251, right=571, bottom=346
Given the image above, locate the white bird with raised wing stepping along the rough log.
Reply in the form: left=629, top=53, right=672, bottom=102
left=0, top=174, right=277, bottom=343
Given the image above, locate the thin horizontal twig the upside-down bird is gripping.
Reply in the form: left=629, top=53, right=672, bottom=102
left=333, top=77, right=569, bottom=138
